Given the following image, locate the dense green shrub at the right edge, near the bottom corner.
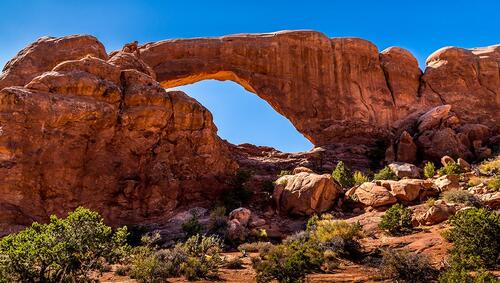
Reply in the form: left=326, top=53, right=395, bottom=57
left=443, top=208, right=500, bottom=270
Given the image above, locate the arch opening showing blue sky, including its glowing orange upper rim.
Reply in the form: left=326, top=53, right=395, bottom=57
left=171, top=80, right=313, bottom=152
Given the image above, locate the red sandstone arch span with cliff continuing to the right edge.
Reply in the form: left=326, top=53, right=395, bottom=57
left=140, top=31, right=500, bottom=146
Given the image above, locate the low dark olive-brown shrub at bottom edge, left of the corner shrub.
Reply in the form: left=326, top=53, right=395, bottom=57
left=381, top=249, right=437, bottom=282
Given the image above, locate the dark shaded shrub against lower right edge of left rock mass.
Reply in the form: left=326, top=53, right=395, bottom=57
left=222, top=170, right=253, bottom=211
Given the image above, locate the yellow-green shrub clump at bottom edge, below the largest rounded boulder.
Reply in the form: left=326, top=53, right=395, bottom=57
left=250, top=216, right=362, bottom=282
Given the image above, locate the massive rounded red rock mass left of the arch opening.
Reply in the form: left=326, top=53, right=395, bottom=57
left=0, top=36, right=237, bottom=233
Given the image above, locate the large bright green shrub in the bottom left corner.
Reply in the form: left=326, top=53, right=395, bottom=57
left=0, top=207, right=128, bottom=282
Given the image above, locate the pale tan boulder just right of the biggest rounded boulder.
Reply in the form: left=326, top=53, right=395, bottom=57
left=352, top=182, right=397, bottom=207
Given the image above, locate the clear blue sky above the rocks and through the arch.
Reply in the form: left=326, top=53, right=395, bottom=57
left=0, top=0, right=500, bottom=151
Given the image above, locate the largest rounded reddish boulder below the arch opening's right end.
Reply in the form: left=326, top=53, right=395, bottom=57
left=273, top=172, right=341, bottom=215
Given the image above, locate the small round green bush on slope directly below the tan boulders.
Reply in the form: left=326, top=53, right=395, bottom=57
left=379, top=203, right=413, bottom=235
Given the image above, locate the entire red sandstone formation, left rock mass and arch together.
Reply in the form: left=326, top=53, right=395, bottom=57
left=0, top=31, right=500, bottom=233
